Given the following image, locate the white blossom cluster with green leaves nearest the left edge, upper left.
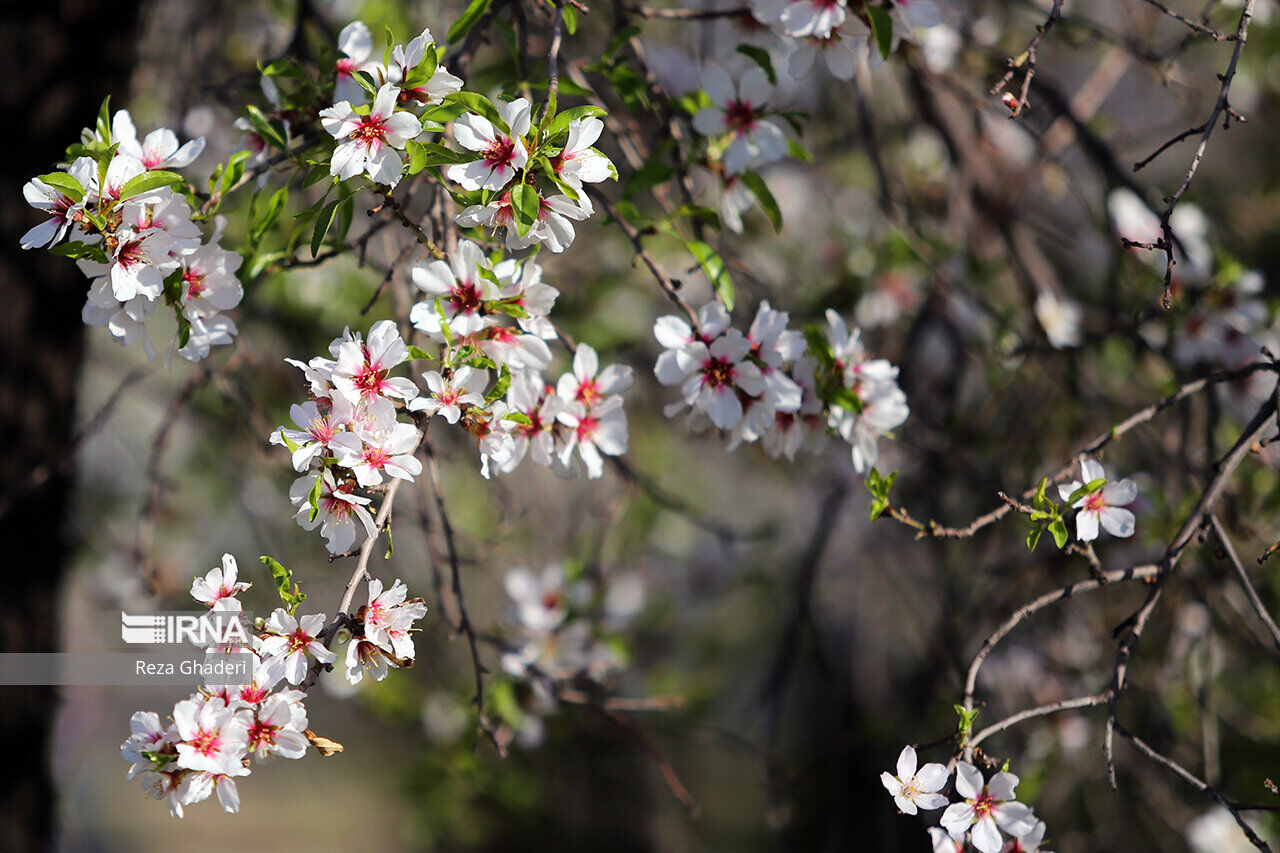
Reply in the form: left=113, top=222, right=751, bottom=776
left=22, top=104, right=243, bottom=361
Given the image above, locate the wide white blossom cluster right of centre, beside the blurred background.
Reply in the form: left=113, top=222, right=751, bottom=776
left=654, top=302, right=909, bottom=474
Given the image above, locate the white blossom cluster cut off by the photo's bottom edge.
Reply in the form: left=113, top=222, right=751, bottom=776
left=881, top=747, right=1044, bottom=853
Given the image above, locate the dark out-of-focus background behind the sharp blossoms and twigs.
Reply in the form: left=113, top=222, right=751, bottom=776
left=0, top=0, right=1280, bottom=853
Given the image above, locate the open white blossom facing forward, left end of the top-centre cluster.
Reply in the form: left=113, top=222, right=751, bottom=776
left=320, top=83, right=422, bottom=187
